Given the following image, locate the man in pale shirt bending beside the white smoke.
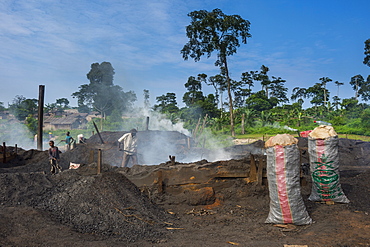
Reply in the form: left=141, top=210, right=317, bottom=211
left=118, top=129, right=137, bottom=167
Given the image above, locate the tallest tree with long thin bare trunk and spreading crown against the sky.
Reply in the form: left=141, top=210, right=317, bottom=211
left=181, top=9, right=251, bottom=136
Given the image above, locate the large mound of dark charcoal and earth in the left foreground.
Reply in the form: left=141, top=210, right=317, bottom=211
left=0, top=146, right=170, bottom=242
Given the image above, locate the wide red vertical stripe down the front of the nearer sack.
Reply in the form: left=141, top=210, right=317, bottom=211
left=275, top=145, right=293, bottom=223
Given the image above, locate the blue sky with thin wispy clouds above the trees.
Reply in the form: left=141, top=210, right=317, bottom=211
left=0, top=0, right=370, bottom=106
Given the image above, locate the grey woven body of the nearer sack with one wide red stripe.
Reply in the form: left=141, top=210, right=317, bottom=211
left=265, top=144, right=312, bottom=225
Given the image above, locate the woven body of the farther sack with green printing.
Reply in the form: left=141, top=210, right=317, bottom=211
left=308, top=136, right=349, bottom=203
